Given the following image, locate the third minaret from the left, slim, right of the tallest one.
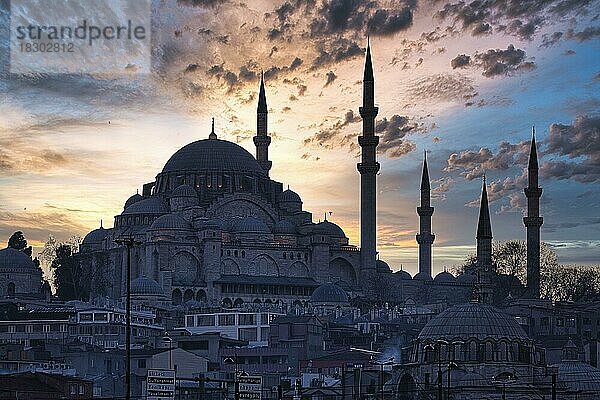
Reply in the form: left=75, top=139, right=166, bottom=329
left=417, top=153, right=435, bottom=277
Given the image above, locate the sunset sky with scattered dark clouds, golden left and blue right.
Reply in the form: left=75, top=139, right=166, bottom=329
left=0, top=0, right=600, bottom=273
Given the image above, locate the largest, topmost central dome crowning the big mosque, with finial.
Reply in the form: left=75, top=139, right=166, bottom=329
left=162, top=139, right=265, bottom=175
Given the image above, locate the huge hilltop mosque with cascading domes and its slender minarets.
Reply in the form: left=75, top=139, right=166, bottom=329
left=79, top=46, right=541, bottom=307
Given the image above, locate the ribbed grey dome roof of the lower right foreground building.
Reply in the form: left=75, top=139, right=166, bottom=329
left=419, top=303, right=528, bottom=341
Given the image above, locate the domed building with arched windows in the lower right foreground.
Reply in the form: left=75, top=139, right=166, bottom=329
left=395, top=302, right=551, bottom=400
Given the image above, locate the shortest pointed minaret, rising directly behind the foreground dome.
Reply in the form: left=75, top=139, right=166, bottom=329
left=476, top=175, right=492, bottom=303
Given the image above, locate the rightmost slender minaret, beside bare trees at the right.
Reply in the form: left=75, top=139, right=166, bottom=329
left=523, top=128, right=544, bottom=299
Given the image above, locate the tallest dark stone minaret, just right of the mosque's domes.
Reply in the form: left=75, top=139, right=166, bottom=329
left=357, top=44, right=379, bottom=275
